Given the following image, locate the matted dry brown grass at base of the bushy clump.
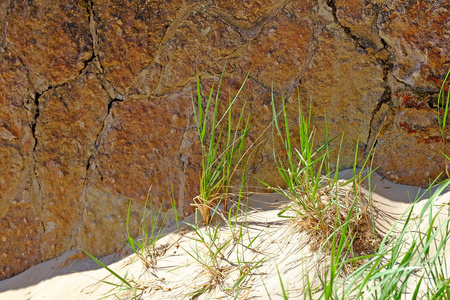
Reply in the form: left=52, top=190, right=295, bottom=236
left=291, top=179, right=382, bottom=256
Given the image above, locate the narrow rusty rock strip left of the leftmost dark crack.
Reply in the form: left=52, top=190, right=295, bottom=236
left=0, top=47, right=41, bottom=278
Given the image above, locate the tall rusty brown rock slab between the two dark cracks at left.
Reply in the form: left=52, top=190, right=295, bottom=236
left=35, top=73, right=109, bottom=260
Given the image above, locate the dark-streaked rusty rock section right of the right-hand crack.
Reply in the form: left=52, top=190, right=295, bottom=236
left=375, top=1, right=450, bottom=186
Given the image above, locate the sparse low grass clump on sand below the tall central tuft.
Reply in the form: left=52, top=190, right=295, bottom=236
left=182, top=195, right=264, bottom=299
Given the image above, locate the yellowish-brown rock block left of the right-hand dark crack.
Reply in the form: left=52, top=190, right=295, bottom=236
left=299, top=15, right=385, bottom=168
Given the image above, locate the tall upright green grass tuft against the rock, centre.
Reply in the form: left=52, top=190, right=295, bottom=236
left=192, top=69, right=251, bottom=224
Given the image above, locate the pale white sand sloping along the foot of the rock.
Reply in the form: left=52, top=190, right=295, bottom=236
left=0, top=171, right=450, bottom=300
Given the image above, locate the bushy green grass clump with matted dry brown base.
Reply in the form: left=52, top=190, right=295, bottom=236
left=272, top=92, right=381, bottom=262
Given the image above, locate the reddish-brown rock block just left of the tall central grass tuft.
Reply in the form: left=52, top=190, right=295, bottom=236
left=96, top=93, right=196, bottom=213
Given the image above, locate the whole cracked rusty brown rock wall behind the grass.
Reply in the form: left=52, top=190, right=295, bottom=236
left=0, top=0, right=450, bottom=279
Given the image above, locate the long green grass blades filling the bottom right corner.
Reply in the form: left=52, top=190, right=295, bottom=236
left=335, top=180, right=450, bottom=299
